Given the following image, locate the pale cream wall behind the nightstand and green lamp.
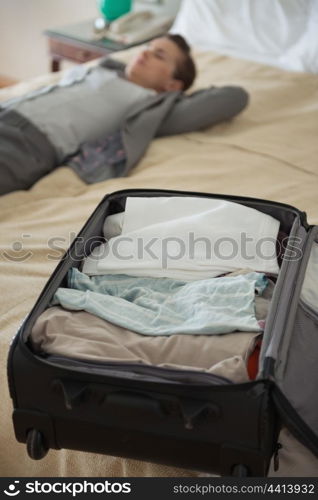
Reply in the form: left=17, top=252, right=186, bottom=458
left=0, top=0, right=181, bottom=80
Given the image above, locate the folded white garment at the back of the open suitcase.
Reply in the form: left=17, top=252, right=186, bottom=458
left=83, top=196, right=279, bottom=280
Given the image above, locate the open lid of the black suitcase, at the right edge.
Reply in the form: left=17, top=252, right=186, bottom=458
left=261, top=226, right=318, bottom=457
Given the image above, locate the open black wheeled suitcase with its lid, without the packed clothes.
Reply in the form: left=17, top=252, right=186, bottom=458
left=8, top=189, right=318, bottom=476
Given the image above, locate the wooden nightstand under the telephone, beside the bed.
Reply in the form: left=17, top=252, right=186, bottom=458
left=44, top=19, right=132, bottom=71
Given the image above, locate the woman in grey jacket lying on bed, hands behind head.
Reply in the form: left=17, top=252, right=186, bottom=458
left=0, top=34, right=248, bottom=194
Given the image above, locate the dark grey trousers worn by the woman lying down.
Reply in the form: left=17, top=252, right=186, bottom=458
left=0, top=110, right=56, bottom=194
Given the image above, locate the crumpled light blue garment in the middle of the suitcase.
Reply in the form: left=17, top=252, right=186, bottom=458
left=52, top=268, right=268, bottom=335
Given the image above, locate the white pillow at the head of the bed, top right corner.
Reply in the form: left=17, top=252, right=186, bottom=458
left=170, top=0, right=318, bottom=73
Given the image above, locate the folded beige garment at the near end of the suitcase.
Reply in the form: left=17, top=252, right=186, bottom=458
left=31, top=307, right=257, bottom=382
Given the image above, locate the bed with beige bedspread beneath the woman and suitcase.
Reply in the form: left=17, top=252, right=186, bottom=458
left=0, top=2, right=318, bottom=477
